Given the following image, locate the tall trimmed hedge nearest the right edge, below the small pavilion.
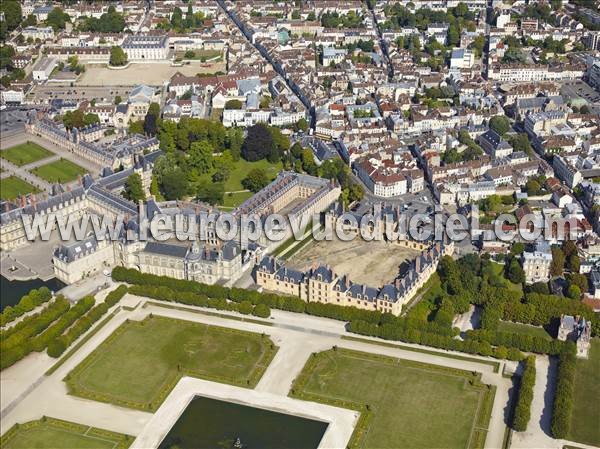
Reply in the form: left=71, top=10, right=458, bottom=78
left=550, top=342, right=576, bottom=438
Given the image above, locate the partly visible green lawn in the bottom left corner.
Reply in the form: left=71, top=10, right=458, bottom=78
left=0, top=418, right=133, bottom=449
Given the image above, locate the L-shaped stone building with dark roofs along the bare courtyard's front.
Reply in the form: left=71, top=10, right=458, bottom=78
left=255, top=242, right=454, bottom=316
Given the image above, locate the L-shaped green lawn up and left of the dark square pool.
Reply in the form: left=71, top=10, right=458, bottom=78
left=65, top=316, right=277, bottom=410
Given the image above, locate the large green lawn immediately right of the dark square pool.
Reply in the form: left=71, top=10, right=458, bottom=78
left=291, top=348, right=494, bottom=449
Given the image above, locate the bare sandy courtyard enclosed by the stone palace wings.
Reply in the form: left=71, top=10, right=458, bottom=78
left=286, top=237, right=419, bottom=287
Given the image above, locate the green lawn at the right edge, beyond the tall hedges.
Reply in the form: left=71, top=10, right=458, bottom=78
left=568, top=338, right=600, bottom=446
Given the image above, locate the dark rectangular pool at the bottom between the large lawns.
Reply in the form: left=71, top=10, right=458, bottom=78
left=159, top=396, right=327, bottom=449
